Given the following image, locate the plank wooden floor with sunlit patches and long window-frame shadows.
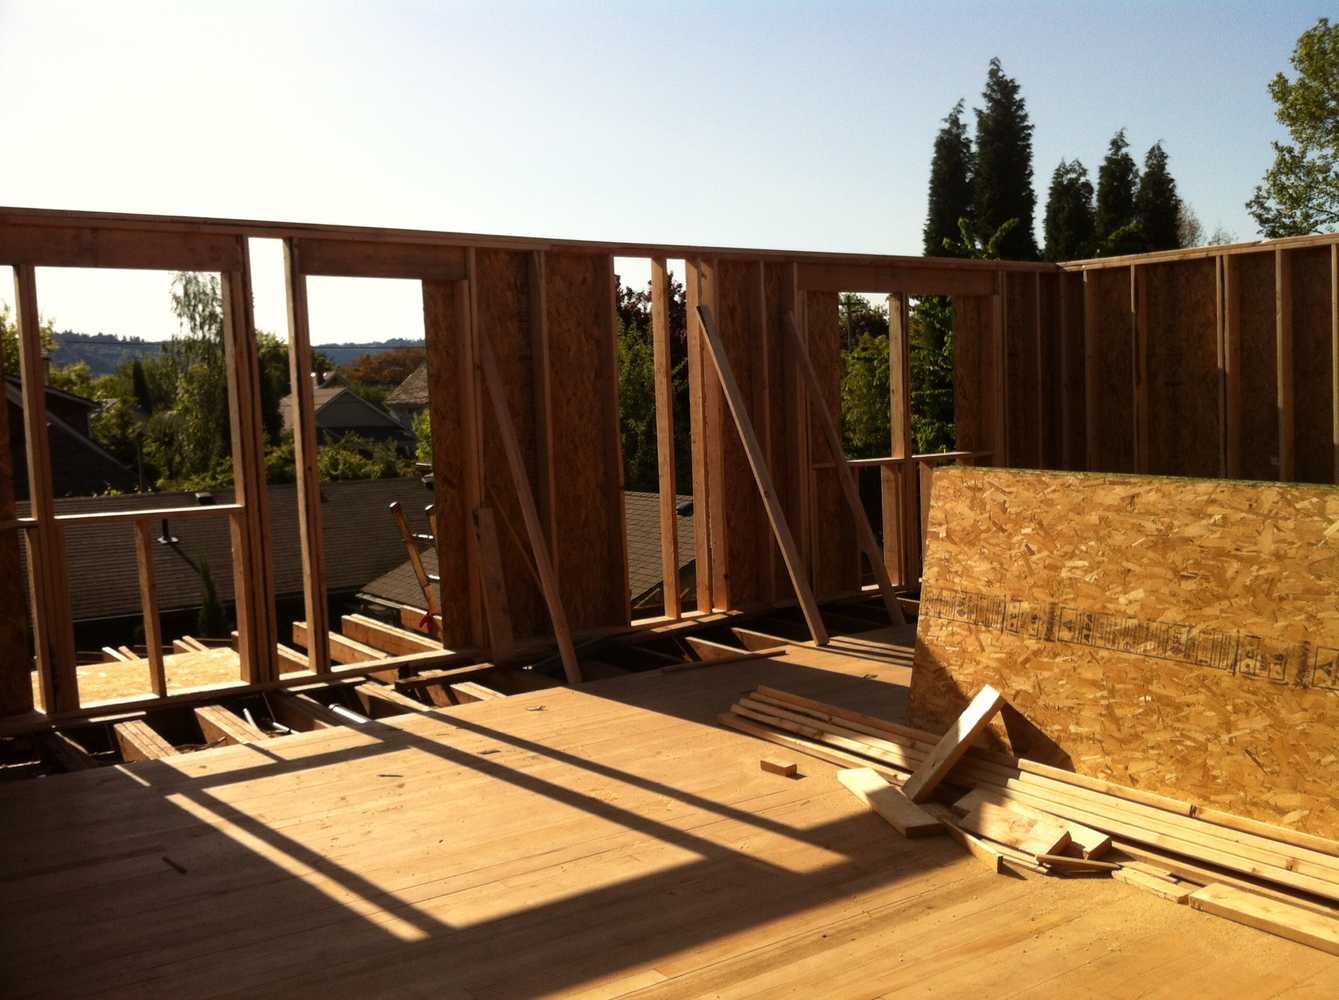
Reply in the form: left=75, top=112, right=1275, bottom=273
left=0, top=629, right=1339, bottom=1000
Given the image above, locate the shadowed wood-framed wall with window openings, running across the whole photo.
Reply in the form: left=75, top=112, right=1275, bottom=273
left=0, top=200, right=1339, bottom=715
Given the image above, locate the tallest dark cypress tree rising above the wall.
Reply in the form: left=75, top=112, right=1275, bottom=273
left=973, top=59, right=1038, bottom=260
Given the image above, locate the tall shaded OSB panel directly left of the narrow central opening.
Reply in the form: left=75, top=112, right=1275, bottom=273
left=545, top=253, right=628, bottom=628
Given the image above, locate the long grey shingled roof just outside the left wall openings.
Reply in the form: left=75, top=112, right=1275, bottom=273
left=19, top=478, right=432, bottom=621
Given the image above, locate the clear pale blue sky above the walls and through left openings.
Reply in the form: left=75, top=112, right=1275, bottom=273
left=0, top=0, right=1335, bottom=343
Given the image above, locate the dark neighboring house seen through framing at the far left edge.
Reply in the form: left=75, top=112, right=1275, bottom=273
left=4, top=378, right=138, bottom=501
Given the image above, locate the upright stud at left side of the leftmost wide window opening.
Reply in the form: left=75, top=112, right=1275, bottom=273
left=13, top=264, right=79, bottom=715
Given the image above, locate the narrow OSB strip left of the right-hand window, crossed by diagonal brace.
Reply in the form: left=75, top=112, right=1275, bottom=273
left=805, top=292, right=860, bottom=600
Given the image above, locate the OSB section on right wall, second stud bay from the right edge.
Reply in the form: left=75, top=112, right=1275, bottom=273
left=1228, top=252, right=1279, bottom=479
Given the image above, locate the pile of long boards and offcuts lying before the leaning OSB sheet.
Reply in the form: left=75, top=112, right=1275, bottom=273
left=720, top=685, right=1339, bottom=953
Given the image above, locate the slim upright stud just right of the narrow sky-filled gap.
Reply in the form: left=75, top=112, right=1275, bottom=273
left=284, top=240, right=329, bottom=673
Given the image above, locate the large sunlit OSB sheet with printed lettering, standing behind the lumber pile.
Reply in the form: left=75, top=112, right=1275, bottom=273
left=911, top=469, right=1339, bottom=837
